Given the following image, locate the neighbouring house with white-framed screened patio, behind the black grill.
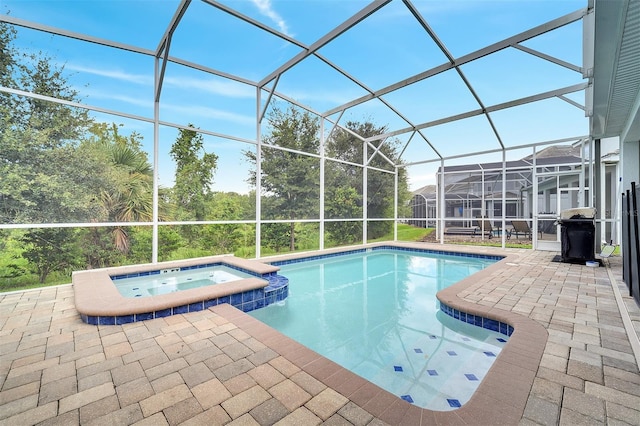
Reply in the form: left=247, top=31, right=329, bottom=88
left=409, top=144, right=619, bottom=240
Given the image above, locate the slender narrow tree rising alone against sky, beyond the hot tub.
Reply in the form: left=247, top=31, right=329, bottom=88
left=170, top=124, right=218, bottom=220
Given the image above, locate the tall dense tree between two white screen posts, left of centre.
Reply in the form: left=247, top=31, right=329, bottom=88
left=244, top=106, right=320, bottom=250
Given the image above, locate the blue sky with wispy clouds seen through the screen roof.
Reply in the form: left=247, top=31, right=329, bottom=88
left=0, top=0, right=588, bottom=193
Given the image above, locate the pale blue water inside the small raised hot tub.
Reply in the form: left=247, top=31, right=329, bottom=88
left=114, top=265, right=253, bottom=297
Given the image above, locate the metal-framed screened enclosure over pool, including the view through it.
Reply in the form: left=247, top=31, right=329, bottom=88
left=0, top=0, right=640, bottom=282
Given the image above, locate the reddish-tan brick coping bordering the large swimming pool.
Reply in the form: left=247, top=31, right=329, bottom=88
left=219, top=242, right=548, bottom=425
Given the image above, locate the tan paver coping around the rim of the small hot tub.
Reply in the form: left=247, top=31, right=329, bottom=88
left=72, top=255, right=280, bottom=318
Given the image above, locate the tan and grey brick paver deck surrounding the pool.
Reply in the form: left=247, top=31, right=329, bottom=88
left=0, top=244, right=640, bottom=426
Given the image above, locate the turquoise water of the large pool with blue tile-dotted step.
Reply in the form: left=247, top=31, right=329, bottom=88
left=249, top=250, right=508, bottom=411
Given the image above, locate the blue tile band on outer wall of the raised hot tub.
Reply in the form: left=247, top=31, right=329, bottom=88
left=80, top=272, right=289, bottom=325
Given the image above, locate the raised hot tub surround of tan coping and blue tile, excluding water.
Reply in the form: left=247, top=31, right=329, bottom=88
left=72, top=256, right=289, bottom=325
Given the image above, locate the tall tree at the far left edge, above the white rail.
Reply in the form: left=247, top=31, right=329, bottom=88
left=0, top=24, right=99, bottom=223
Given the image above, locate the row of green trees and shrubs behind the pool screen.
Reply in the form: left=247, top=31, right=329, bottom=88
left=0, top=24, right=409, bottom=290
